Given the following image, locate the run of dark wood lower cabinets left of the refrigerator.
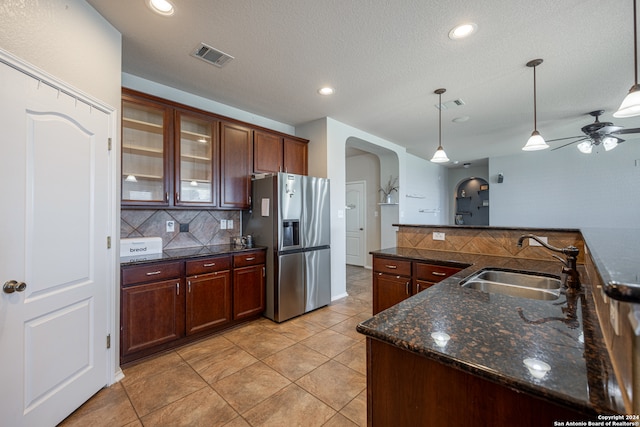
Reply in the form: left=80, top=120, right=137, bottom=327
left=120, top=249, right=265, bottom=364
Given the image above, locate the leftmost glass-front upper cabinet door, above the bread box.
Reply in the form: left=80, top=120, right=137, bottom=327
left=122, top=97, right=170, bottom=205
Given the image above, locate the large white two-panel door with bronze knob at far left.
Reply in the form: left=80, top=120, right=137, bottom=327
left=0, top=57, right=112, bottom=426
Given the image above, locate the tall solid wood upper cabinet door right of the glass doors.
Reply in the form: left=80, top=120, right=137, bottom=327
left=220, top=122, right=253, bottom=209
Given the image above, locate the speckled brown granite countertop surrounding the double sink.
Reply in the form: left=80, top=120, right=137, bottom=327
left=357, top=248, right=625, bottom=415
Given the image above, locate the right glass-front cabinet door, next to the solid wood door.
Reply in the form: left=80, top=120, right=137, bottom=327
left=175, top=111, right=217, bottom=206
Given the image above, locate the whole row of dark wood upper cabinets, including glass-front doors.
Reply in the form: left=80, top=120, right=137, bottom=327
left=121, top=88, right=309, bottom=209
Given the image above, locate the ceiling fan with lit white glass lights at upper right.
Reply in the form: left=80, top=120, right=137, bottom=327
left=547, top=110, right=640, bottom=154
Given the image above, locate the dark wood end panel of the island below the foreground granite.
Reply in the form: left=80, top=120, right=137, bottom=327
left=367, top=337, right=591, bottom=427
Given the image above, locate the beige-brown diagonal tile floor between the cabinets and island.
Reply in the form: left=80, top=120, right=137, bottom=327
left=60, top=266, right=372, bottom=427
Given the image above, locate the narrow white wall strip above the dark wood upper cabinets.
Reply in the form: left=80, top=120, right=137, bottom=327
left=122, top=73, right=295, bottom=135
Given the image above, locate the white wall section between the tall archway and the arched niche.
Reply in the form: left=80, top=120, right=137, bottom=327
left=401, top=154, right=449, bottom=225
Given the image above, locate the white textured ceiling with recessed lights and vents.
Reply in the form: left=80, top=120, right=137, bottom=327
left=88, top=0, right=640, bottom=164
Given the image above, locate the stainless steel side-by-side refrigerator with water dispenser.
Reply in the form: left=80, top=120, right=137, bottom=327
left=244, top=173, right=331, bottom=322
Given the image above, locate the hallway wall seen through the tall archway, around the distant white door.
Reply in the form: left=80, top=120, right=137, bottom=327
left=346, top=153, right=384, bottom=268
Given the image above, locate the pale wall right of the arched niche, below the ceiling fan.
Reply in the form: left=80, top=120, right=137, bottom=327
left=488, top=141, right=640, bottom=228
